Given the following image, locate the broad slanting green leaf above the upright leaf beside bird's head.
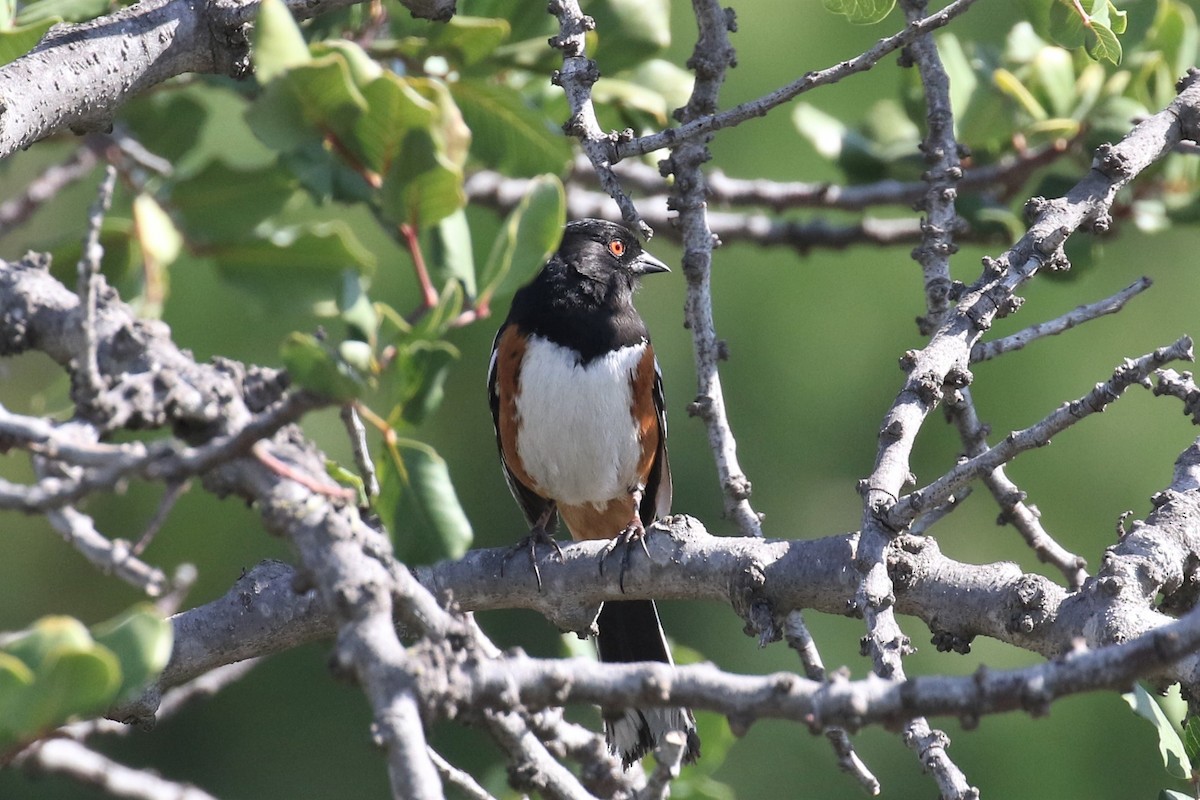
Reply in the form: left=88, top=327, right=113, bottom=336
left=450, top=78, right=572, bottom=178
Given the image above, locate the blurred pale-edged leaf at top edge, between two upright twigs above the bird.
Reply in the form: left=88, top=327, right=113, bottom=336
left=588, top=0, right=671, bottom=74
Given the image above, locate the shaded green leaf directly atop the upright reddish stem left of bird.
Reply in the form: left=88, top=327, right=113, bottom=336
left=379, top=128, right=467, bottom=228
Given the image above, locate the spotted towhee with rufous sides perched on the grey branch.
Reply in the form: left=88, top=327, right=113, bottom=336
left=487, top=219, right=700, bottom=766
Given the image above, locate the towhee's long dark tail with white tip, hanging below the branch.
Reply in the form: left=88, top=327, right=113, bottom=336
left=596, top=600, right=700, bottom=768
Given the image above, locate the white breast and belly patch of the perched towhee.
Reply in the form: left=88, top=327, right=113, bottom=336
left=516, top=336, right=646, bottom=505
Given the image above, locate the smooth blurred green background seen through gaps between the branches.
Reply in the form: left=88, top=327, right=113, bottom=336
left=0, top=0, right=1200, bottom=800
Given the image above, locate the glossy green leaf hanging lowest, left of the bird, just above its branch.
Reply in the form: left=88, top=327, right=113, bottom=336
left=376, top=441, right=474, bottom=564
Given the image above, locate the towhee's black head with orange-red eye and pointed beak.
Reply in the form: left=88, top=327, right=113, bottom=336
left=558, top=219, right=671, bottom=291
